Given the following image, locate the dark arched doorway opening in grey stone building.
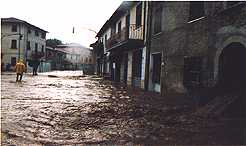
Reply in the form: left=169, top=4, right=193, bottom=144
left=218, top=42, right=246, bottom=92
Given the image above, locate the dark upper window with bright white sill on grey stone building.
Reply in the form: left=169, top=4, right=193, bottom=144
left=189, top=1, right=205, bottom=21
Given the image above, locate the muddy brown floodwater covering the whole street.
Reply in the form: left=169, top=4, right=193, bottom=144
left=1, top=71, right=246, bottom=145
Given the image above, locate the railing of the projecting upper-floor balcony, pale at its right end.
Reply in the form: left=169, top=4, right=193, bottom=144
left=105, top=25, right=143, bottom=49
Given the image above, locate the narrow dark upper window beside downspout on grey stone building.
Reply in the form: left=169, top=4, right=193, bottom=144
left=154, top=2, right=162, bottom=34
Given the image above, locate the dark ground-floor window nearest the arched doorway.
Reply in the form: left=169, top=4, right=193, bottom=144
left=183, top=57, right=202, bottom=88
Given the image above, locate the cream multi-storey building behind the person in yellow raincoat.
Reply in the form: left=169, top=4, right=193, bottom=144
left=1, top=17, right=47, bottom=70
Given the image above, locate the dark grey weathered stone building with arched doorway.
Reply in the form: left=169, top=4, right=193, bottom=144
left=146, top=1, right=246, bottom=95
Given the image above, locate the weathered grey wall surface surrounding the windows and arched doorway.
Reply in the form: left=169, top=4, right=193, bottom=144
left=150, top=2, right=246, bottom=94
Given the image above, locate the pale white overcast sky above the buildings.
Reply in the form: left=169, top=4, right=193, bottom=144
left=0, top=0, right=122, bottom=47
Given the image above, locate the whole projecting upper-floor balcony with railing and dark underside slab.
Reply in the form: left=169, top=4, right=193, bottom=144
left=105, top=25, right=144, bottom=51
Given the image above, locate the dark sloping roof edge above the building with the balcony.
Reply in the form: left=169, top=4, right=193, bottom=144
left=96, top=1, right=139, bottom=37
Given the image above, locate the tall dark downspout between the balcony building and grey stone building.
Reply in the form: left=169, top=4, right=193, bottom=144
left=144, top=1, right=152, bottom=90
